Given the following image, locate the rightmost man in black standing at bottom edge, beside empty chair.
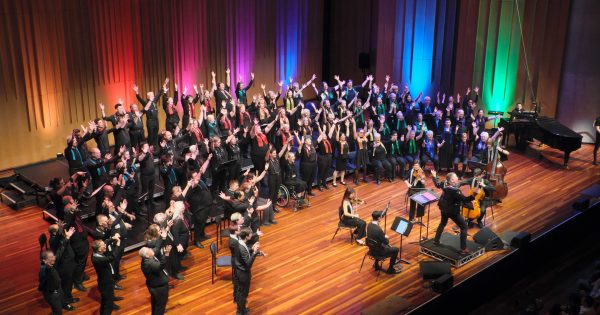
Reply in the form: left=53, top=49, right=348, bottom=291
left=232, top=228, right=260, bottom=315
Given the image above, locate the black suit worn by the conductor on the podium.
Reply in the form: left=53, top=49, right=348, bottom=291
left=433, top=177, right=475, bottom=250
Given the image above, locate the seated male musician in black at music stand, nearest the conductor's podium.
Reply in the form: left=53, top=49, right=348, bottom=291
left=367, top=211, right=401, bottom=274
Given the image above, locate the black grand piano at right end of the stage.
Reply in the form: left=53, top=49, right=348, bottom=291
left=498, top=115, right=583, bottom=167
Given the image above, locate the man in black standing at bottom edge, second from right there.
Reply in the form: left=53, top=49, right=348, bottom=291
left=139, top=245, right=171, bottom=315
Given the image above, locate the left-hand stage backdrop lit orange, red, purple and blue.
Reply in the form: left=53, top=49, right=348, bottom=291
left=0, top=0, right=323, bottom=169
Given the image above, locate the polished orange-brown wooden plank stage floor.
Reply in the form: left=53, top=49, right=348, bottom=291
left=0, top=145, right=600, bottom=314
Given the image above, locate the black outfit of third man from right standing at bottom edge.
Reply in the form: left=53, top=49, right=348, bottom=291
left=92, top=249, right=115, bottom=315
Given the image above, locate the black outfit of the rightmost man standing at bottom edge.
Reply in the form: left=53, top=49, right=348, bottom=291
left=232, top=241, right=256, bottom=314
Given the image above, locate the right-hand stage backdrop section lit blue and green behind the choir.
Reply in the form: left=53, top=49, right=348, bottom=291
left=328, top=0, right=570, bottom=117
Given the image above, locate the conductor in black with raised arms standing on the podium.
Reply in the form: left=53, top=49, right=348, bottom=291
left=431, top=170, right=479, bottom=254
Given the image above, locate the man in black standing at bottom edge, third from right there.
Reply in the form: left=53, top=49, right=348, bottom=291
left=92, top=239, right=120, bottom=315
